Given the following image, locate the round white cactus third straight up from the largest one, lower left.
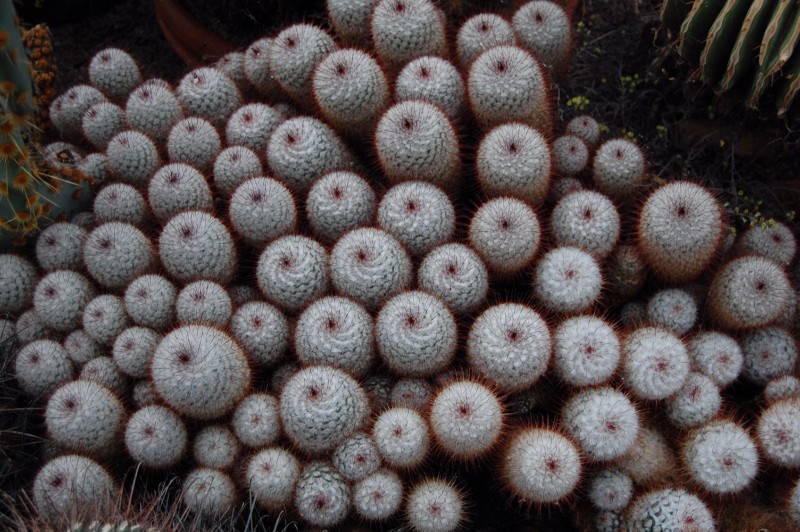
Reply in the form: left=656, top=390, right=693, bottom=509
left=147, top=163, right=214, bottom=223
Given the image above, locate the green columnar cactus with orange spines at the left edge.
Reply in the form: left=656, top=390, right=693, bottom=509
left=0, top=0, right=86, bottom=248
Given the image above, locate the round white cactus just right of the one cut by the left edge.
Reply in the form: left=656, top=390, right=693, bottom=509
left=33, top=270, right=94, bottom=332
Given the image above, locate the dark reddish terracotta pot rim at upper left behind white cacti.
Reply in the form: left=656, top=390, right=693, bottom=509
left=153, top=0, right=236, bottom=67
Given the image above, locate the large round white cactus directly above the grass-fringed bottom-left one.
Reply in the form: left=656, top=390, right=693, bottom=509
left=45, top=379, right=126, bottom=457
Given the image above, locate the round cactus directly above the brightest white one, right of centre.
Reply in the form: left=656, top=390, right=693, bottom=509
left=550, top=190, right=620, bottom=259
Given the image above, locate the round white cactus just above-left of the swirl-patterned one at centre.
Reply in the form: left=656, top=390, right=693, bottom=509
left=306, top=171, right=375, bottom=242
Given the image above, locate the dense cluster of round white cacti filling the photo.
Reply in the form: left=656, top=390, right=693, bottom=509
left=0, top=0, right=800, bottom=531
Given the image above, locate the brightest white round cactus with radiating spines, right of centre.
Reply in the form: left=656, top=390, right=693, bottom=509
left=533, top=246, right=603, bottom=314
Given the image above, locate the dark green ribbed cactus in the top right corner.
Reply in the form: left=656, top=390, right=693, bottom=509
left=661, top=0, right=800, bottom=117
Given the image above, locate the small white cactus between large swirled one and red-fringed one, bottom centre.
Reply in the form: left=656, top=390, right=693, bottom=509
left=372, top=406, right=430, bottom=469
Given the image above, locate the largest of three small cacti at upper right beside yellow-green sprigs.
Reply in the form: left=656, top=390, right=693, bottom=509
left=592, top=138, right=648, bottom=202
